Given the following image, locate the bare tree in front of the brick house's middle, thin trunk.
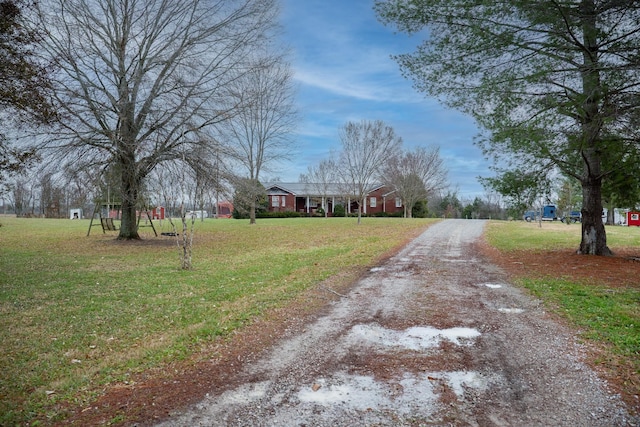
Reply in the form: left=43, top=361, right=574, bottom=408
left=338, top=120, right=402, bottom=224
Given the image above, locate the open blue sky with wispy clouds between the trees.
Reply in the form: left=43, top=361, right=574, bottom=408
left=272, top=0, right=491, bottom=200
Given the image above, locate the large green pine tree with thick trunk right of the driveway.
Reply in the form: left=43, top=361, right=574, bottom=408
left=375, top=0, right=640, bottom=255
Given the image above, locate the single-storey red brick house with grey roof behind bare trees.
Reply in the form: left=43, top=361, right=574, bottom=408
left=265, top=182, right=404, bottom=215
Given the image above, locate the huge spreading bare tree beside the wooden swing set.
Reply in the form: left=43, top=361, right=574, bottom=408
left=32, top=0, right=277, bottom=239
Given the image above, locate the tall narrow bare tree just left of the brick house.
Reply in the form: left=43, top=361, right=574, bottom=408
left=224, top=56, right=297, bottom=224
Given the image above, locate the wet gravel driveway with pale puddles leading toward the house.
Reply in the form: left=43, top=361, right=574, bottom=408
left=156, top=220, right=639, bottom=426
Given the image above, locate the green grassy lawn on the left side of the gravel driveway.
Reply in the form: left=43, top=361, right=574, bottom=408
left=0, top=217, right=432, bottom=425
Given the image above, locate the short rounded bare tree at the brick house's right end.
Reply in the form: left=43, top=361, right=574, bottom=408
left=383, top=147, right=447, bottom=218
